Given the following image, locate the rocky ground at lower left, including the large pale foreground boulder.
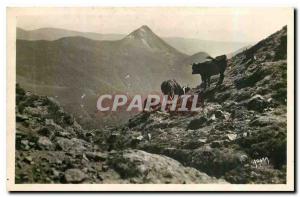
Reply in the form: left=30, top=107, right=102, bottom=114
left=15, top=85, right=226, bottom=183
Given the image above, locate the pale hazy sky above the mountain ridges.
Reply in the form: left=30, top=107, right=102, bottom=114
left=17, top=8, right=292, bottom=42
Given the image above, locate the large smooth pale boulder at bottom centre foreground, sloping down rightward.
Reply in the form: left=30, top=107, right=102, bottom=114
left=109, top=150, right=226, bottom=184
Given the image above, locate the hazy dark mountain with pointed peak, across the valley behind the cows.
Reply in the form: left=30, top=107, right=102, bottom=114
left=16, top=26, right=202, bottom=129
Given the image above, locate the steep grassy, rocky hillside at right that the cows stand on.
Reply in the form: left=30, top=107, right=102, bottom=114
left=102, top=26, right=287, bottom=184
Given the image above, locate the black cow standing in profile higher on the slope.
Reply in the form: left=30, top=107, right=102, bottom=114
left=192, top=55, right=227, bottom=89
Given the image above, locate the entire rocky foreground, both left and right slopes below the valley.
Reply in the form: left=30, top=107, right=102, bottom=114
left=16, top=27, right=287, bottom=184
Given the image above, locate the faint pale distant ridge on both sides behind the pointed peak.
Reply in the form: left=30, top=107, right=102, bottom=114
left=17, top=28, right=252, bottom=56
